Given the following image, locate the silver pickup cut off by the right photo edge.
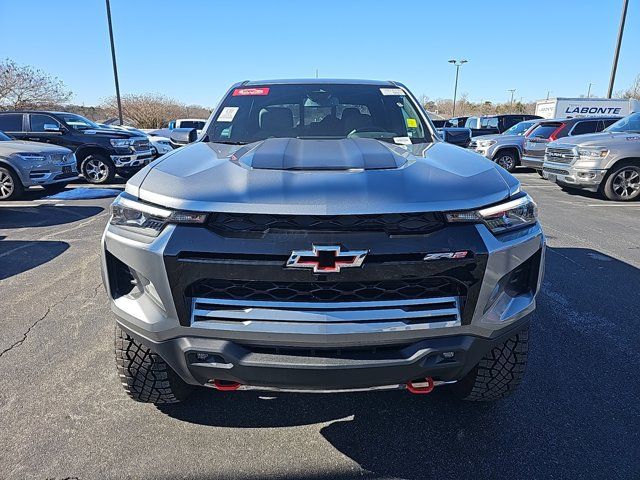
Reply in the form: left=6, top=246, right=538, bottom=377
left=542, top=113, right=640, bottom=201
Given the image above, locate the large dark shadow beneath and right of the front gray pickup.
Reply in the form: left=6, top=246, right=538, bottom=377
left=159, top=248, right=640, bottom=479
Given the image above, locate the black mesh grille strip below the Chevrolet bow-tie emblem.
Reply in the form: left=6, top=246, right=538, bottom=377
left=186, top=277, right=466, bottom=302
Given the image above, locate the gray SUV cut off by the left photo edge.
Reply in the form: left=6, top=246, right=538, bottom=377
left=0, top=128, right=78, bottom=200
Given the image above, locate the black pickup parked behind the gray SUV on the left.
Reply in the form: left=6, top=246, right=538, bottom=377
left=0, top=111, right=154, bottom=183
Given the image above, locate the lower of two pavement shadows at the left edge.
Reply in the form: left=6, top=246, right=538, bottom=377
left=0, top=238, right=69, bottom=280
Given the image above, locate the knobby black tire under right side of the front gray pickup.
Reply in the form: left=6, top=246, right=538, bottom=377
left=452, top=328, right=529, bottom=402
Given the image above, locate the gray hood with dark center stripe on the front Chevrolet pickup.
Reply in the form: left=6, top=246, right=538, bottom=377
left=131, top=139, right=519, bottom=215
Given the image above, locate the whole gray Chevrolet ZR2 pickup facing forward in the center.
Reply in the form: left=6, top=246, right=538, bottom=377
left=102, top=80, right=545, bottom=403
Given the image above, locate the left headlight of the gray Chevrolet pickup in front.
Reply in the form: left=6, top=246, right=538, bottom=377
left=109, top=193, right=207, bottom=237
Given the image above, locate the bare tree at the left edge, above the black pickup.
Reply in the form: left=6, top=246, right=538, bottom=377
left=0, top=59, right=72, bottom=110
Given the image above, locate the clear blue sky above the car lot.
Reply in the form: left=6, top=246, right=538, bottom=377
left=0, top=0, right=640, bottom=107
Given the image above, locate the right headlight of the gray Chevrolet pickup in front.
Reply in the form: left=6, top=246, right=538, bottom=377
left=446, top=195, right=538, bottom=233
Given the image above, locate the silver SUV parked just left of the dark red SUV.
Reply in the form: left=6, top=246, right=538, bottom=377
left=469, top=120, right=539, bottom=172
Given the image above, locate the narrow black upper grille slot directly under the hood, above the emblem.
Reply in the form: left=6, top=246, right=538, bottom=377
left=208, top=213, right=445, bottom=236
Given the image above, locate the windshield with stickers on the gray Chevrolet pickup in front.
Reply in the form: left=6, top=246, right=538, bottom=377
left=207, top=84, right=431, bottom=144
